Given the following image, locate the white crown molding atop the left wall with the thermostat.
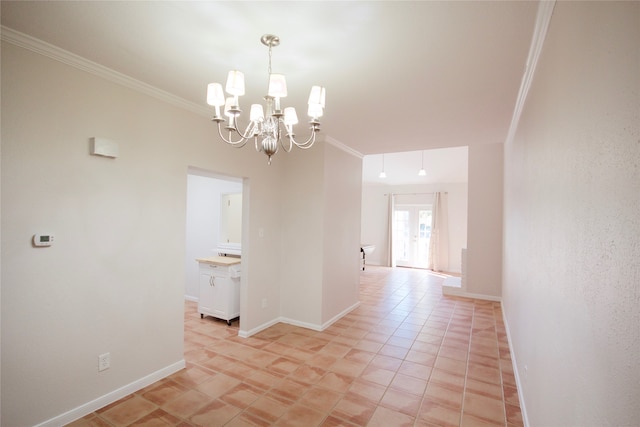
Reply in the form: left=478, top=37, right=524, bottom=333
left=1, top=25, right=212, bottom=117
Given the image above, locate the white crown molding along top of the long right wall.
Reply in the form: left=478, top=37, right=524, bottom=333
left=506, top=0, right=556, bottom=144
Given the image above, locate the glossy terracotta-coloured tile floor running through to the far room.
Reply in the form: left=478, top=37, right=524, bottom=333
left=71, top=266, right=523, bottom=427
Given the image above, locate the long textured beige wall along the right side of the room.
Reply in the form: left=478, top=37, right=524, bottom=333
left=503, top=2, right=640, bottom=427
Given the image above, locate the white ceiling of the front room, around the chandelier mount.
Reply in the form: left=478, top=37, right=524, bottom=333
left=1, top=0, right=538, bottom=174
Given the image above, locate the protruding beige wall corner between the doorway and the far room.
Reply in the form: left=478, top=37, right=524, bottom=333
left=281, top=141, right=362, bottom=329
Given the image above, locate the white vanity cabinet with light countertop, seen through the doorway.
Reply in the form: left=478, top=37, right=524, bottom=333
left=196, top=257, right=241, bottom=325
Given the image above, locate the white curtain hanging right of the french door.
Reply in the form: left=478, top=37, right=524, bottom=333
left=428, top=193, right=449, bottom=271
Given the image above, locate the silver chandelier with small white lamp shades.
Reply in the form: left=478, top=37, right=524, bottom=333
left=207, top=34, right=325, bottom=164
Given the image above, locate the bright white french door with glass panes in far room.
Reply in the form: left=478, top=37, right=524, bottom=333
left=393, top=205, right=432, bottom=268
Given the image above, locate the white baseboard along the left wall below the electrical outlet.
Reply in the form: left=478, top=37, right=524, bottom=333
left=36, top=359, right=186, bottom=427
